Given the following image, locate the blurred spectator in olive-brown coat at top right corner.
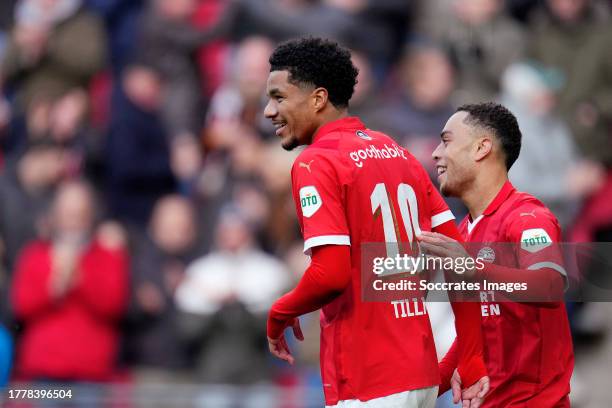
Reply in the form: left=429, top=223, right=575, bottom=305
left=530, top=0, right=612, bottom=168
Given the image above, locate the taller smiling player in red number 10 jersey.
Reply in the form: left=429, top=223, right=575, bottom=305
left=264, top=38, right=486, bottom=408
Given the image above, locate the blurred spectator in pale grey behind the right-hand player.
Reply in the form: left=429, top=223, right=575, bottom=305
left=500, top=63, right=593, bottom=230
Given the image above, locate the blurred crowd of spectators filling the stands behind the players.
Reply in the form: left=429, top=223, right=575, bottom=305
left=0, top=0, right=612, bottom=402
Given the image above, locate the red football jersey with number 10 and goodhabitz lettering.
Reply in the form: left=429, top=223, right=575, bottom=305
left=291, top=117, right=453, bottom=405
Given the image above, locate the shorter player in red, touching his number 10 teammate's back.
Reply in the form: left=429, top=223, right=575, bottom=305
left=421, top=103, right=574, bottom=408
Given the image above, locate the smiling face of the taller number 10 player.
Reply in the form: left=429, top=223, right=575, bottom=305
left=264, top=71, right=317, bottom=150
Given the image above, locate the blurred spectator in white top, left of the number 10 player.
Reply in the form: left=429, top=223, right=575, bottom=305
left=176, top=207, right=290, bottom=383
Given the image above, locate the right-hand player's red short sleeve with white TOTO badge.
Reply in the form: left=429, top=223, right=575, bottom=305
left=507, top=207, right=567, bottom=278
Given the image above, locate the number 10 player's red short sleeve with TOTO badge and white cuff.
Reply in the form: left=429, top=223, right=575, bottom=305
left=291, top=150, right=351, bottom=254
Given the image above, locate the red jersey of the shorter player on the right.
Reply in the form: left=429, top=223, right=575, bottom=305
left=459, top=182, right=574, bottom=407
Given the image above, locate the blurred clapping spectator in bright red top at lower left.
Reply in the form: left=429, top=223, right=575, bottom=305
left=11, top=182, right=128, bottom=381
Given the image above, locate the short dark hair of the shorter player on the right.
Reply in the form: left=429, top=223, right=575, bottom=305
left=457, top=102, right=522, bottom=170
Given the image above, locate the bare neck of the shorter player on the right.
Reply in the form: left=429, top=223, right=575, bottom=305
left=461, top=170, right=508, bottom=220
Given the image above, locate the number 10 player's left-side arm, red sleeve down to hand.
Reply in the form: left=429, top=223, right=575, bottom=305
left=267, top=149, right=351, bottom=363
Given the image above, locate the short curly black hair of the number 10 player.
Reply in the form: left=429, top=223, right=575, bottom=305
left=270, top=37, right=358, bottom=108
